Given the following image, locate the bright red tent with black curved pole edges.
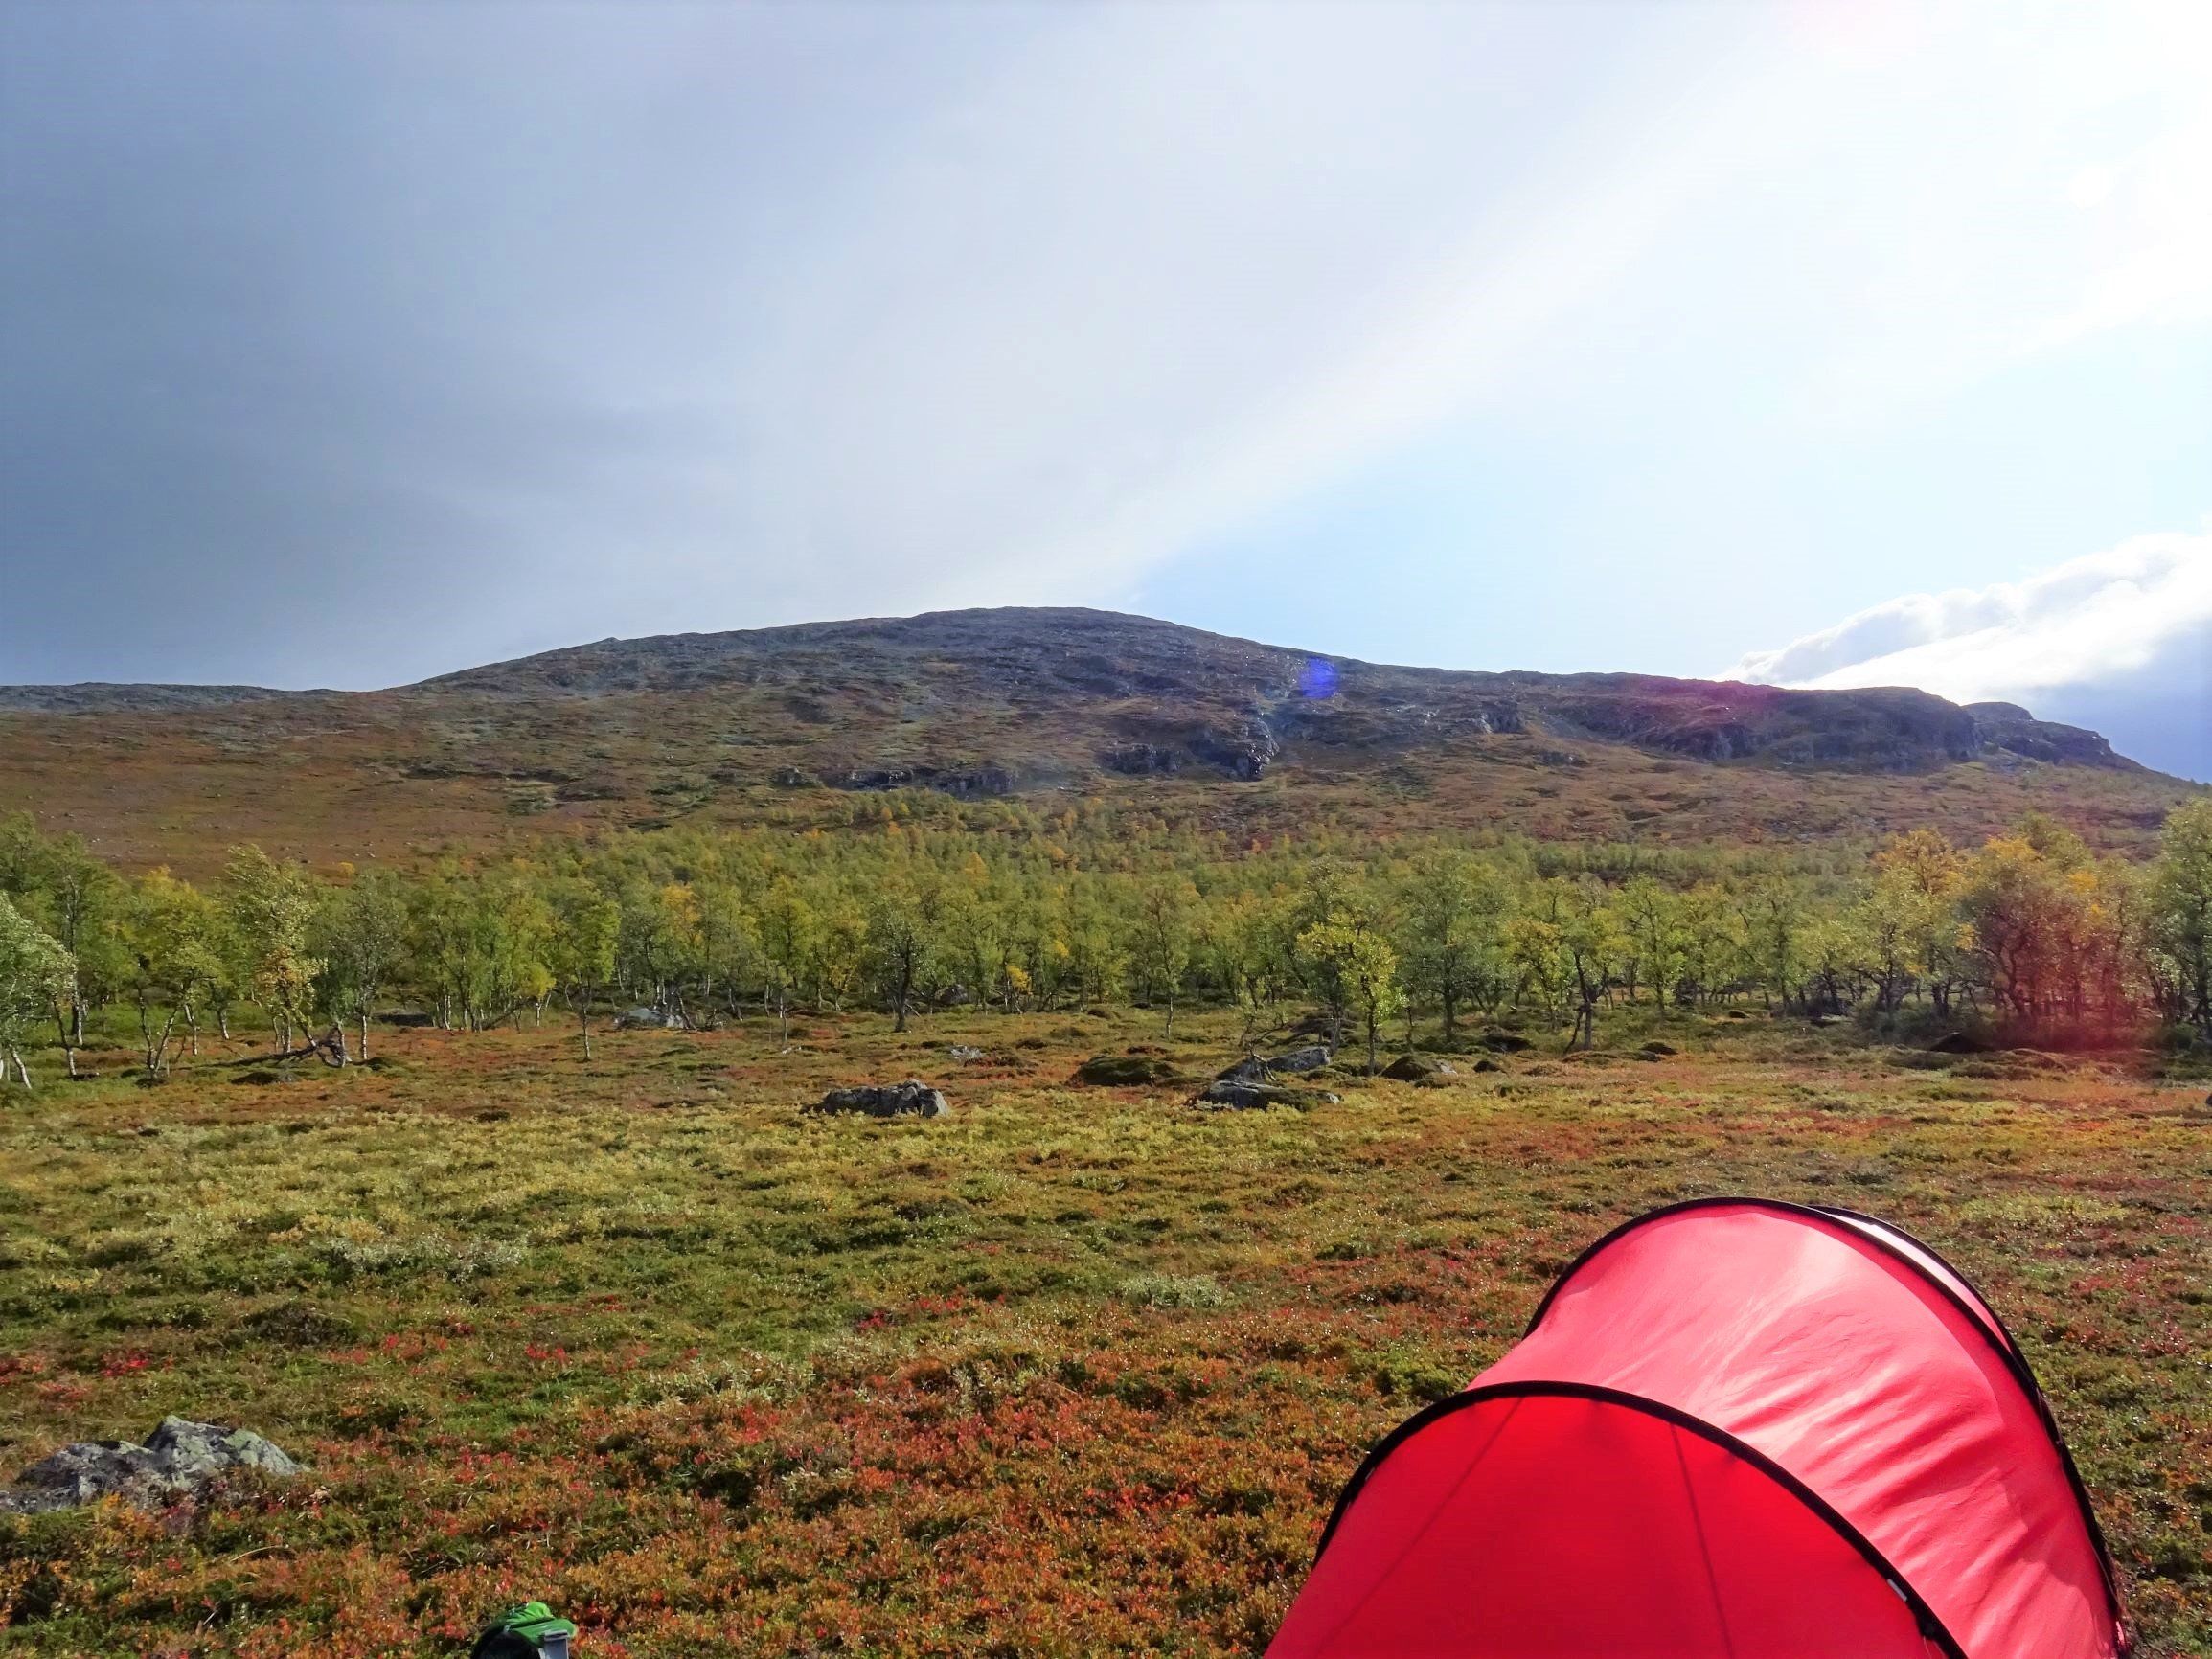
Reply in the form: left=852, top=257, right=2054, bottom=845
left=1267, top=1199, right=2126, bottom=1659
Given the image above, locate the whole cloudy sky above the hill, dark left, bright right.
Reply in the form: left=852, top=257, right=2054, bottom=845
left=0, top=0, right=2212, bottom=777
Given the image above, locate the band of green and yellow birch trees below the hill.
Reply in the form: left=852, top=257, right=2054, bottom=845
left=0, top=796, right=2212, bottom=1086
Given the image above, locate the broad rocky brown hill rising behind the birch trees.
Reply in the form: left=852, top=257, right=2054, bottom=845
left=0, top=610, right=2190, bottom=867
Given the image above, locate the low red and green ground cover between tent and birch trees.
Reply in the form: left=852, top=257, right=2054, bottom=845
left=0, top=1015, right=2212, bottom=1654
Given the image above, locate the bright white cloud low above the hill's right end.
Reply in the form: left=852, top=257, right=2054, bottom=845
left=1732, top=529, right=2212, bottom=777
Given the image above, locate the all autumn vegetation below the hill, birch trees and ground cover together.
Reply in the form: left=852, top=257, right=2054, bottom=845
left=0, top=796, right=2212, bottom=1654
